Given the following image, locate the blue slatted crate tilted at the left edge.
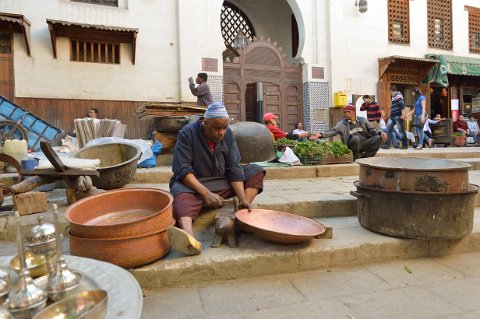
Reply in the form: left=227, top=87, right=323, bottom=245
left=0, top=96, right=63, bottom=151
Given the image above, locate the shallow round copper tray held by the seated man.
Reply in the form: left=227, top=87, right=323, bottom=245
left=235, top=209, right=325, bottom=244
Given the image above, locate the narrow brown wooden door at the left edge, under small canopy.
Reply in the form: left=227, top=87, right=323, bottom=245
left=0, top=33, right=15, bottom=101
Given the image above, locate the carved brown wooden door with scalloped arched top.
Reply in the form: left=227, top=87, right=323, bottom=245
left=223, top=38, right=303, bottom=131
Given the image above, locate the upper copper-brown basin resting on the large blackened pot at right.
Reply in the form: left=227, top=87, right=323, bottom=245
left=356, top=157, right=471, bottom=192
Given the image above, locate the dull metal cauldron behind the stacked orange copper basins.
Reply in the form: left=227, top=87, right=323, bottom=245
left=75, top=143, right=142, bottom=189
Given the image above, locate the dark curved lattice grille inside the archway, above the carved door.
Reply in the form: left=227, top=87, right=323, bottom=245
left=220, top=1, right=255, bottom=47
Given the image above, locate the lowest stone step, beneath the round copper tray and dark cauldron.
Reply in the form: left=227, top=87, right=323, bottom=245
left=130, top=209, right=480, bottom=289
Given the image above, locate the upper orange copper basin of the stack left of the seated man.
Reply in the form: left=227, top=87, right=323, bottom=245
left=65, top=188, right=173, bottom=239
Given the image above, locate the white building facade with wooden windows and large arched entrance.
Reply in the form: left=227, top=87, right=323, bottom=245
left=0, top=0, right=480, bottom=138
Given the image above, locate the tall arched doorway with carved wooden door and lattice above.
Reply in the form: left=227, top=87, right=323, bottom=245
left=221, top=0, right=303, bottom=131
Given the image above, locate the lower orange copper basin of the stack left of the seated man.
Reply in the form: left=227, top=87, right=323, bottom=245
left=69, top=231, right=170, bottom=268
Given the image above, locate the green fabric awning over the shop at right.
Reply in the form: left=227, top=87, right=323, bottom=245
left=423, top=54, right=480, bottom=87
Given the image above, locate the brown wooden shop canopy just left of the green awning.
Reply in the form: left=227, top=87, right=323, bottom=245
left=378, top=55, right=438, bottom=83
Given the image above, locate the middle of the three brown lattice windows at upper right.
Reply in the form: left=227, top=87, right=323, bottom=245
left=427, top=0, right=452, bottom=50
